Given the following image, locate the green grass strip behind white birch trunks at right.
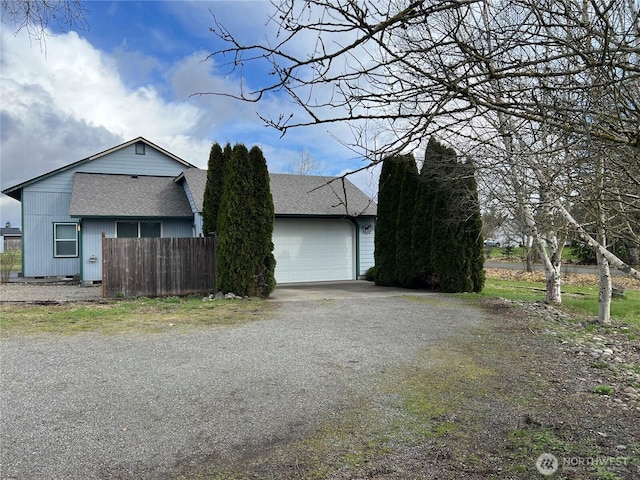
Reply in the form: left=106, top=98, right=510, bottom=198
left=478, top=278, right=640, bottom=328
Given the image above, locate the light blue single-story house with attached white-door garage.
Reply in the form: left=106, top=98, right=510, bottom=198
left=3, top=137, right=376, bottom=283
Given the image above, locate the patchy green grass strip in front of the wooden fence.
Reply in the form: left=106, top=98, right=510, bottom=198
left=0, top=297, right=274, bottom=336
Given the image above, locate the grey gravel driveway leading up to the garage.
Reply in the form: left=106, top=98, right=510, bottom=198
left=0, top=284, right=485, bottom=479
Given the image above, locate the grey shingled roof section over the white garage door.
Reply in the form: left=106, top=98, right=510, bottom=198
left=176, top=168, right=376, bottom=217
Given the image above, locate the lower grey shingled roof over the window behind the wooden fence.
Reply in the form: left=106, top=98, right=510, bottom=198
left=69, top=173, right=193, bottom=217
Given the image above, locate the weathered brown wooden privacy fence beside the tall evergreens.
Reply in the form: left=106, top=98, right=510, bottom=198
left=102, top=234, right=217, bottom=298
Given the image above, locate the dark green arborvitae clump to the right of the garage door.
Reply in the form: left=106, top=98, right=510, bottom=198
left=375, top=139, right=484, bottom=292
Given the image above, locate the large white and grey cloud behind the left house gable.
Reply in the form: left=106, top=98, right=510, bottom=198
left=0, top=29, right=208, bottom=225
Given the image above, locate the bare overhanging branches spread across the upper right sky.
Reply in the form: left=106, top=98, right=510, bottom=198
left=212, top=0, right=640, bottom=150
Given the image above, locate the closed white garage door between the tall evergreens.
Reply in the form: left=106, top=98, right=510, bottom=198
left=273, top=218, right=355, bottom=283
